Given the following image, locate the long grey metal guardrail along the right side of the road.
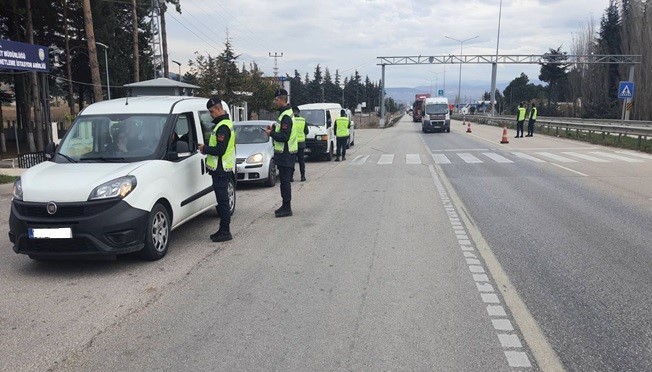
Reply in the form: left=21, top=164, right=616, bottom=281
left=453, top=115, right=652, bottom=149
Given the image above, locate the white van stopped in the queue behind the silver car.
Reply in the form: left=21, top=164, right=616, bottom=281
left=299, top=103, right=342, bottom=161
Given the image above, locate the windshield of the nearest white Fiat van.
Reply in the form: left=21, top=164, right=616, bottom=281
left=55, top=114, right=168, bottom=162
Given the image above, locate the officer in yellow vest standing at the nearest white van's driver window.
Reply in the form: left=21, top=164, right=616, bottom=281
left=199, top=96, right=235, bottom=242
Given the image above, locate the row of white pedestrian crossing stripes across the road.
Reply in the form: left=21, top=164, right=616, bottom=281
left=349, top=151, right=652, bottom=166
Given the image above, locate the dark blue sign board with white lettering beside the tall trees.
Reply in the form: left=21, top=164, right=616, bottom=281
left=0, top=40, right=50, bottom=72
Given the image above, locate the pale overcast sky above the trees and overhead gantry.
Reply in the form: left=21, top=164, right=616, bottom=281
left=166, top=0, right=609, bottom=96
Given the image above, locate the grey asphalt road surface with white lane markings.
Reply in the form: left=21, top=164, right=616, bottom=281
left=0, top=118, right=652, bottom=371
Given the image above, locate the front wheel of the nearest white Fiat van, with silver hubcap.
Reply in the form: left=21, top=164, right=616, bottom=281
left=140, top=203, right=170, bottom=261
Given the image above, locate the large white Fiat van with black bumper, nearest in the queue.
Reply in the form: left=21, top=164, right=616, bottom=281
left=9, top=96, right=236, bottom=260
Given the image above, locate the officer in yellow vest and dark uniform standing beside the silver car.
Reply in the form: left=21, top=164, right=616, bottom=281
left=265, top=89, right=299, bottom=217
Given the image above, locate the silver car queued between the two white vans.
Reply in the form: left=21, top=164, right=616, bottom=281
left=233, top=120, right=276, bottom=187
